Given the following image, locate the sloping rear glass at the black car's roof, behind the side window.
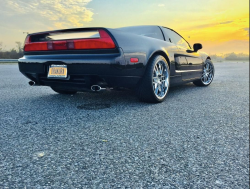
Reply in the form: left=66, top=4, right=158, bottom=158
left=117, top=26, right=164, bottom=40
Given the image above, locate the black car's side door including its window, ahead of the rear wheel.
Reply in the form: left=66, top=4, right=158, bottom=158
left=164, top=28, right=202, bottom=80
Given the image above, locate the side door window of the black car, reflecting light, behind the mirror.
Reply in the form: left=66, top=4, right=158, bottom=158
left=163, top=28, right=190, bottom=49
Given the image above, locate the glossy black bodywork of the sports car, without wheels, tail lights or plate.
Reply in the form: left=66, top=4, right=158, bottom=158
left=18, top=26, right=208, bottom=91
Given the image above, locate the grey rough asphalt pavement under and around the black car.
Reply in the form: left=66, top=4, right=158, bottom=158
left=0, top=62, right=249, bottom=189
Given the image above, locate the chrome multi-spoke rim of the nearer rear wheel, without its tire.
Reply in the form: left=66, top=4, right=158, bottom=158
left=153, top=61, right=169, bottom=99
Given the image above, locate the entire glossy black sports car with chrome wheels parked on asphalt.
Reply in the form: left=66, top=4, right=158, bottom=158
left=18, top=26, right=214, bottom=102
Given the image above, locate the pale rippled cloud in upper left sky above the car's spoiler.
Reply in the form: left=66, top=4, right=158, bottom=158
left=0, top=0, right=94, bottom=28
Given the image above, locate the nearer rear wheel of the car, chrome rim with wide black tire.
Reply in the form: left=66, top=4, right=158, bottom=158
left=137, top=55, right=170, bottom=103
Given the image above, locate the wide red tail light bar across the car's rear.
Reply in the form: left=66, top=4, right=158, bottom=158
left=24, top=29, right=116, bottom=52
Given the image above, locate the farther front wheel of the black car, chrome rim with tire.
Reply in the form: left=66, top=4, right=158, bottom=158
left=193, top=59, right=215, bottom=86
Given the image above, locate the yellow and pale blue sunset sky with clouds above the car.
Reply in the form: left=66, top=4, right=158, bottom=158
left=0, top=0, right=249, bottom=54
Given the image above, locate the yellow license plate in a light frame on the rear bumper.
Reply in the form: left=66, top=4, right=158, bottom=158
left=48, top=65, right=68, bottom=78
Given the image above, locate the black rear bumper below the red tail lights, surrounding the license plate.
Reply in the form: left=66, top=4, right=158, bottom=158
left=18, top=52, right=145, bottom=91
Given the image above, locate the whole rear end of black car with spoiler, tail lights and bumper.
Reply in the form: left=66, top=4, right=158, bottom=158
left=18, top=28, right=144, bottom=91
